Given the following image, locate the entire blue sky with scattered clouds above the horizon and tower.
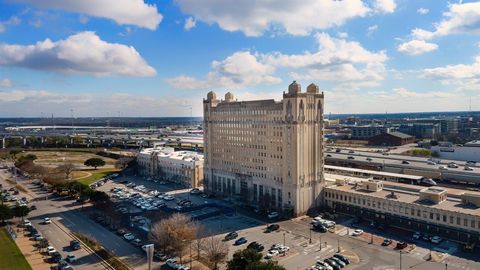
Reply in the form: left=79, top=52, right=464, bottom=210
left=0, top=0, right=480, bottom=117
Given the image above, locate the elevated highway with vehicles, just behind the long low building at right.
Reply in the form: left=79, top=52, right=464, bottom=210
left=325, top=148, right=480, bottom=184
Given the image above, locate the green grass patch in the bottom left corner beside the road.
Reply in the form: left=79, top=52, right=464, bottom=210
left=0, top=228, right=32, bottom=270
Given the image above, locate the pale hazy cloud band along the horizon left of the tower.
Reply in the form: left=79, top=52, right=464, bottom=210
left=0, top=89, right=206, bottom=117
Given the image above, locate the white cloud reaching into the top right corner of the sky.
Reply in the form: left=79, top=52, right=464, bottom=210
left=412, top=2, right=480, bottom=40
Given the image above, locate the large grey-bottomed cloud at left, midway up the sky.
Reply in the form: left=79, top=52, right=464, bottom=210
left=0, top=32, right=156, bottom=76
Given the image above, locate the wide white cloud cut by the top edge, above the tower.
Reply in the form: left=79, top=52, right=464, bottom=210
left=176, top=0, right=372, bottom=36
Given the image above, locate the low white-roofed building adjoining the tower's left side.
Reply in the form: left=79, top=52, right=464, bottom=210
left=137, top=146, right=204, bottom=187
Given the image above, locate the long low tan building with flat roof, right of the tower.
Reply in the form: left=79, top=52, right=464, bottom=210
left=324, top=177, right=480, bottom=243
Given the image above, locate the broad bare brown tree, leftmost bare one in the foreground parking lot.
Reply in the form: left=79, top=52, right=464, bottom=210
left=149, top=213, right=197, bottom=262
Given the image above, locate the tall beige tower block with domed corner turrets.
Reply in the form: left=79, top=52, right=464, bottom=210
left=203, top=82, right=324, bottom=215
